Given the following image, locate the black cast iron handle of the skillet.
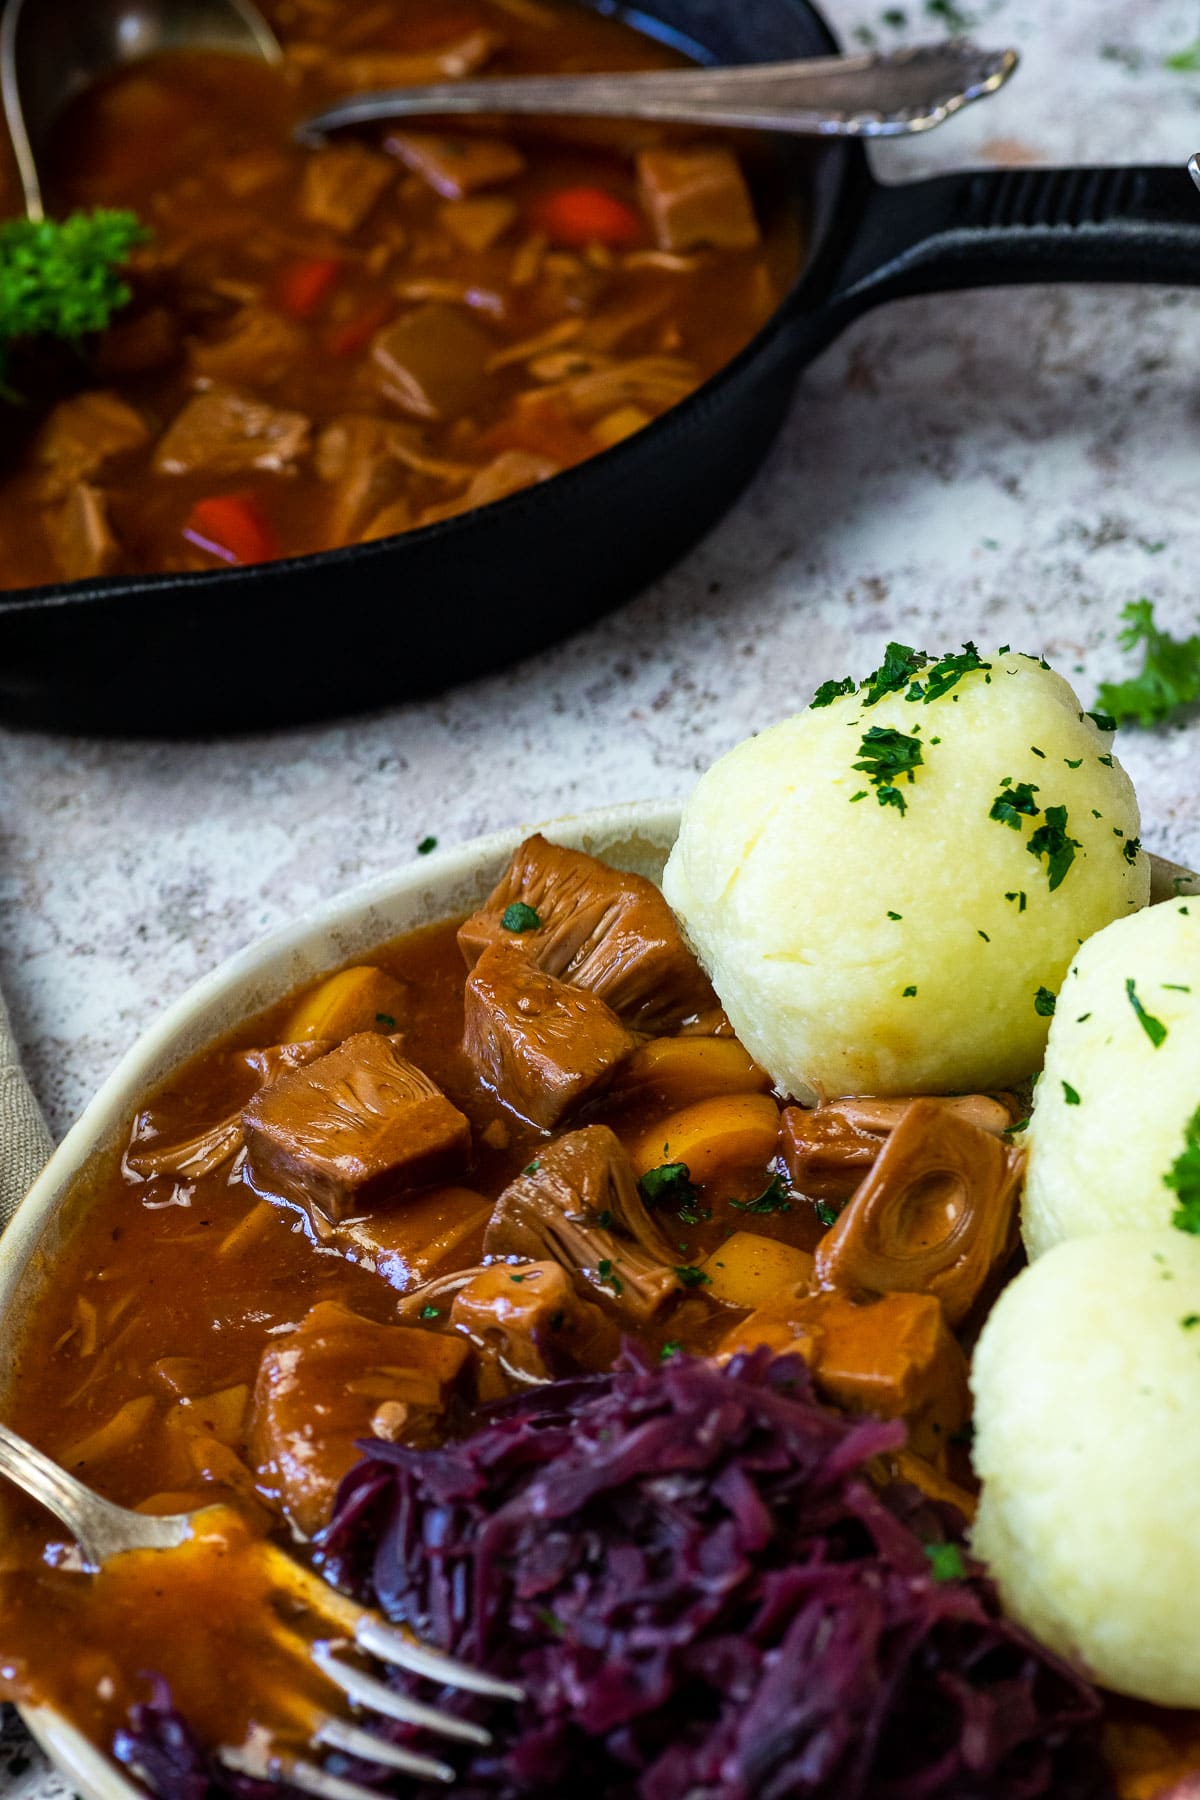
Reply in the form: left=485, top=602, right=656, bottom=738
left=828, top=164, right=1200, bottom=329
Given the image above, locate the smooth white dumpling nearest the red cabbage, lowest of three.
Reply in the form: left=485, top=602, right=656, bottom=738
left=972, top=1229, right=1200, bottom=1706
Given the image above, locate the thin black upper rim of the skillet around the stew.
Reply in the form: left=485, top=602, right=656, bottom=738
left=0, top=0, right=852, bottom=626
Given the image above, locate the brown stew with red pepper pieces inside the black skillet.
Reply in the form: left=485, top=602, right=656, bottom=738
left=0, top=0, right=799, bottom=587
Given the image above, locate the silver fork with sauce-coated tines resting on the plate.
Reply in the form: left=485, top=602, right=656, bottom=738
left=0, top=1424, right=524, bottom=1800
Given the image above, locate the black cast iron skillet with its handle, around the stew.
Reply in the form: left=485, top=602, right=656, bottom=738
left=0, top=0, right=1200, bottom=734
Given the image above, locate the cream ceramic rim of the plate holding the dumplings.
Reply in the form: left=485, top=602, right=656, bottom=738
left=0, top=801, right=1200, bottom=1800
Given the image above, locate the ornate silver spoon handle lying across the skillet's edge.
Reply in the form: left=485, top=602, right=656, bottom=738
left=297, top=40, right=1016, bottom=144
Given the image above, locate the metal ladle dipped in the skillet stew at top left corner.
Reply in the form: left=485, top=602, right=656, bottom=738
left=0, top=0, right=282, bottom=220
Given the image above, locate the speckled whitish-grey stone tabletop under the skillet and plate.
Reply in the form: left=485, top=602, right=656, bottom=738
left=0, top=0, right=1200, bottom=1800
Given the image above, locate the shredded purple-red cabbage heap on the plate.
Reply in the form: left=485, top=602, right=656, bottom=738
left=110, top=1350, right=1110, bottom=1800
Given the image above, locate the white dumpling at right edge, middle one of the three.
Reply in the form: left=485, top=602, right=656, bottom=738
left=1022, top=898, right=1200, bottom=1256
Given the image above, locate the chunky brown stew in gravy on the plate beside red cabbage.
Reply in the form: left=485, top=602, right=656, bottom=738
left=0, top=837, right=1195, bottom=1800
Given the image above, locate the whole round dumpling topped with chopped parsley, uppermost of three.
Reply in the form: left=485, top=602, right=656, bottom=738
left=664, top=644, right=1150, bottom=1100
